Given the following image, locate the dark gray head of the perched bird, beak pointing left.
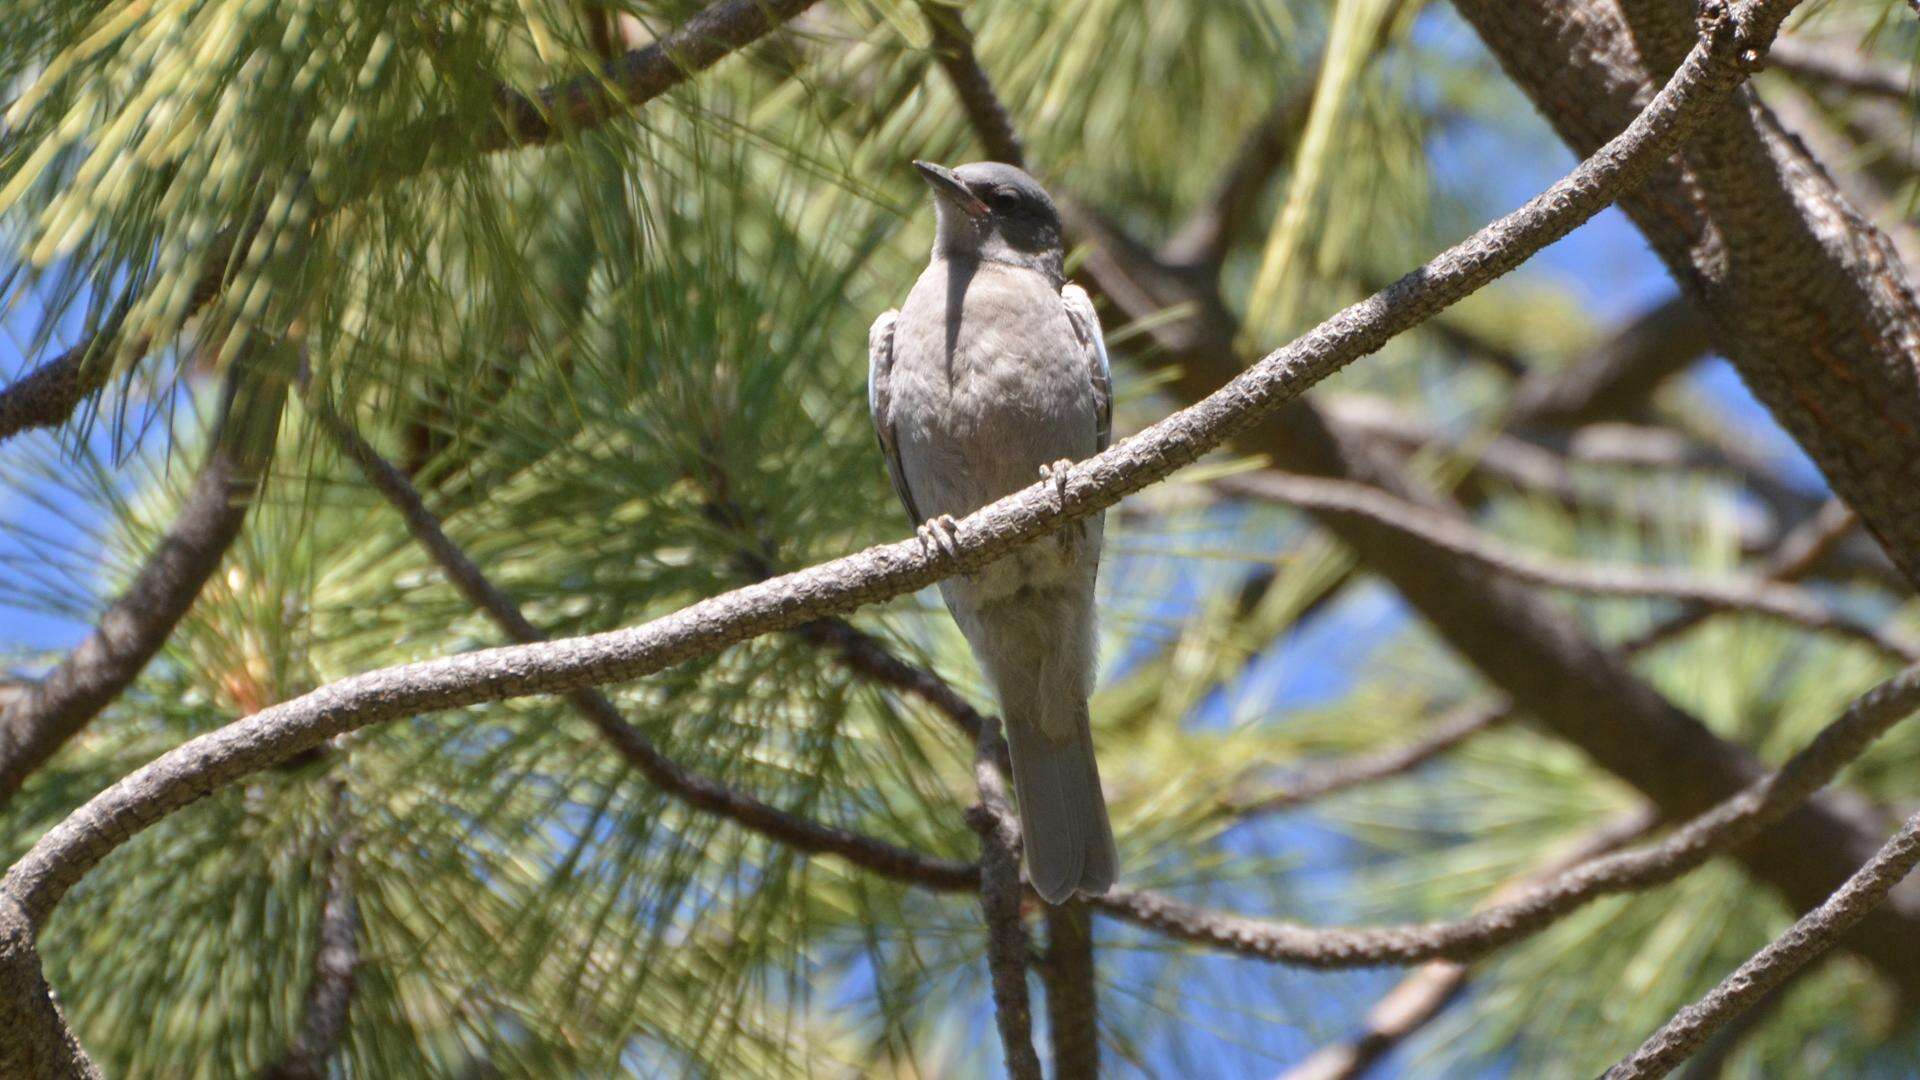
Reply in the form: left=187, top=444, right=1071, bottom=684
left=914, top=161, right=1064, bottom=279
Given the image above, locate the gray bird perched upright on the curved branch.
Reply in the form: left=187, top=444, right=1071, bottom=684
left=868, top=161, right=1116, bottom=903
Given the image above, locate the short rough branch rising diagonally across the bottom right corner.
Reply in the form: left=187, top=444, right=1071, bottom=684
left=1605, top=815, right=1920, bottom=1080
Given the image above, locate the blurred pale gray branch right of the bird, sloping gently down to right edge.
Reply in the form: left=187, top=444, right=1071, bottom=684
left=1215, top=469, right=1920, bottom=663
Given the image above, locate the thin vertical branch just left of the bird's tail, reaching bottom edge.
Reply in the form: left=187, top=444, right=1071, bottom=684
left=968, top=723, right=1041, bottom=1080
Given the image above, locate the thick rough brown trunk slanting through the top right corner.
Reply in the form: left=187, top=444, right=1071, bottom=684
left=1453, top=0, right=1920, bottom=582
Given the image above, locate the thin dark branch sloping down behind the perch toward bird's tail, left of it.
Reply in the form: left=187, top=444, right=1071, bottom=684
left=309, top=398, right=979, bottom=890
